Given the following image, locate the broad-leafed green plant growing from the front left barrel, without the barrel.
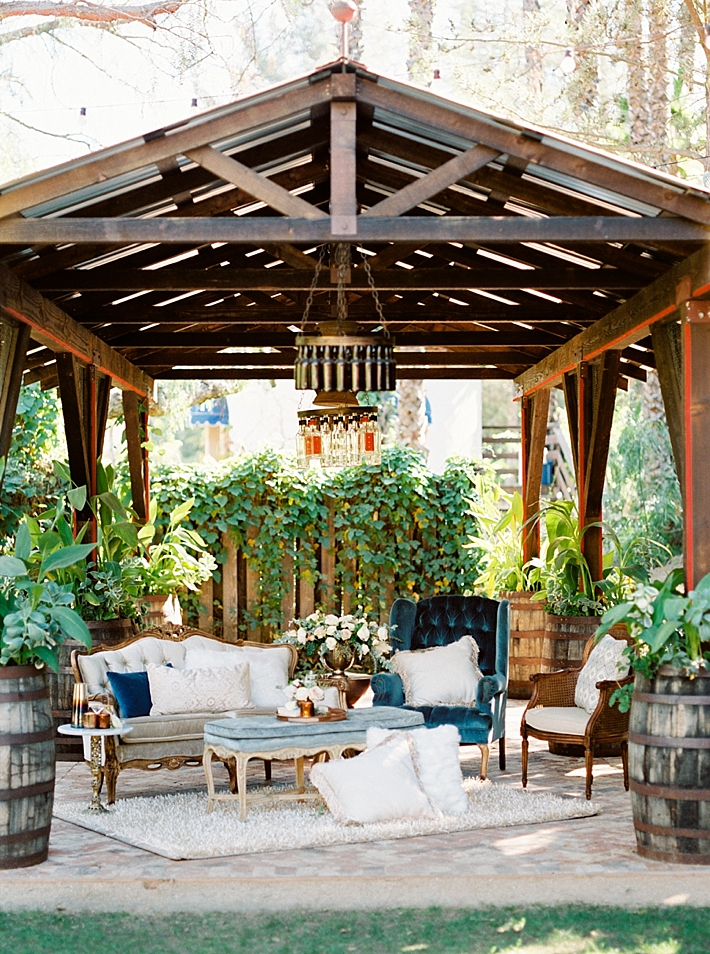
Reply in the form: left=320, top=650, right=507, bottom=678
left=0, top=513, right=93, bottom=672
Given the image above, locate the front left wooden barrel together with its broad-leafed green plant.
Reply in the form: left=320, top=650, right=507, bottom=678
left=0, top=519, right=93, bottom=868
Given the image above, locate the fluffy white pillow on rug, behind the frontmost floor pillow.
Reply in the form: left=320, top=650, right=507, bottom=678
left=367, top=725, right=468, bottom=815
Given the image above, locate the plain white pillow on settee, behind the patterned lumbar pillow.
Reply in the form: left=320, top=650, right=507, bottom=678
left=185, top=646, right=291, bottom=709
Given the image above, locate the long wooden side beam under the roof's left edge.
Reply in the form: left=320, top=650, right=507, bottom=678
left=0, top=266, right=153, bottom=396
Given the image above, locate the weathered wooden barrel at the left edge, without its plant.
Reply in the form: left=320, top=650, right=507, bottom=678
left=0, top=666, right=54, bottom=868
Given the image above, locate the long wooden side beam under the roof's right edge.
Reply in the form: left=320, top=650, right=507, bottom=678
left=516, top=245, right=710, bottom=394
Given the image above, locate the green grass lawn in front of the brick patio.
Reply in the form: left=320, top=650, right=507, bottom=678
left=0, top=901, right=710, bottom=954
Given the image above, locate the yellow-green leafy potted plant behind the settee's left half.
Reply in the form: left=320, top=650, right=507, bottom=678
left=133, top=497, right=217, bottom=625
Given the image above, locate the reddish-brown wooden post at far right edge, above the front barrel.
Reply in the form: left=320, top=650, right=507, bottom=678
left=680, top=301, right=710, bottom=589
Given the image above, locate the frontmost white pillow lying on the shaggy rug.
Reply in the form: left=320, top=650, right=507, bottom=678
left=311, top=732, right=437, bottom=824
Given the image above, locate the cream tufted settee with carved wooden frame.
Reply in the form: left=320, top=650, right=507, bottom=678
left=71, top=625, right=304, bottom=804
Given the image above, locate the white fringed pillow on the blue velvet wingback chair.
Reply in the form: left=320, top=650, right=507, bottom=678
left=392, top=636, right=481, bottom=706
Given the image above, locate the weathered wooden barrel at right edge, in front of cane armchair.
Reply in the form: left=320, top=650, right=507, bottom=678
left=629, top=666, right=710, bottom=865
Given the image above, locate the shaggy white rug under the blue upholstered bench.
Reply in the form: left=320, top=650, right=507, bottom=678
left=54, top=779, right=598, bottom=861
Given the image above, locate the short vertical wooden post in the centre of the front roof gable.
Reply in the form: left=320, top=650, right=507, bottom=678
left=330, top=73, right=357, bottom=236
